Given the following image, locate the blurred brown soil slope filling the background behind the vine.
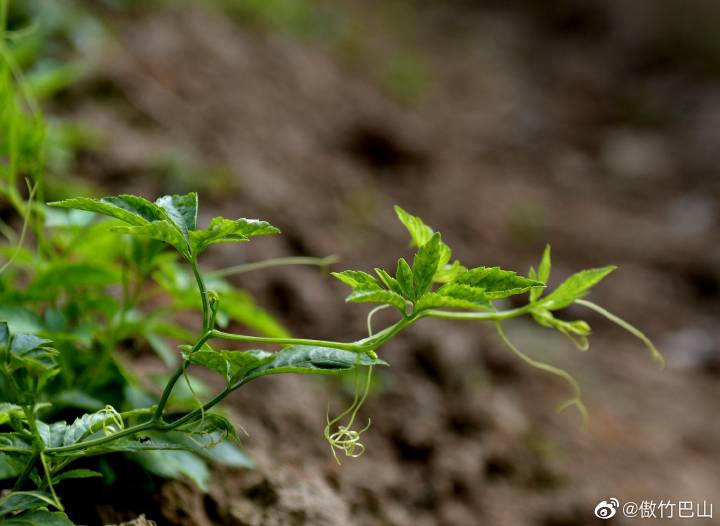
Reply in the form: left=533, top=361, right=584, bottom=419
left=42, top=0, right=720, bottom=526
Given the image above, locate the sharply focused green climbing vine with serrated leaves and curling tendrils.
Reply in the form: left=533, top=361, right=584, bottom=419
left=0, top=193, right=663, bottom=525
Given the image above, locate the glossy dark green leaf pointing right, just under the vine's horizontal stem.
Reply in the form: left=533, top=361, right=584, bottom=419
left=241, top=345, right=387, bottom=383
